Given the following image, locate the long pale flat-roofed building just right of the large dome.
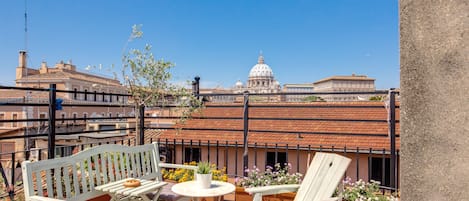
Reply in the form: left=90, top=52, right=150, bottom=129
left=314, top=74, right=376, bottom=101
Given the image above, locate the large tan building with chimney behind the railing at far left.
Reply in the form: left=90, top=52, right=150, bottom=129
left=0, top=51, right=134, bottom=159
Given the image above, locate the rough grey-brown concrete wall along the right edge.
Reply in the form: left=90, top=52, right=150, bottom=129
left=400, top=0, right=469, bottom=201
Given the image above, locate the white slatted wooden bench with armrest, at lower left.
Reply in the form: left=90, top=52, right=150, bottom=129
left=22, top=143, right=196, bottom=201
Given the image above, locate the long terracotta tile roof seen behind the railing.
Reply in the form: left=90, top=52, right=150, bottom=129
left=154, top=102, right=400, bottom=149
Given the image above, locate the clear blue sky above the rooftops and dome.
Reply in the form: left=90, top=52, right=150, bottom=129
left=0, top=0, right=399, bottom=89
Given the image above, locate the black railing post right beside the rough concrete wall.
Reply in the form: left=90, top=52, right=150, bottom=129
left=389, top=88, right=396, bottom=192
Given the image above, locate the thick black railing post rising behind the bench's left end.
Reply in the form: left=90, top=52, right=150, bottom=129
left=47, top=84, right=56, bottom=159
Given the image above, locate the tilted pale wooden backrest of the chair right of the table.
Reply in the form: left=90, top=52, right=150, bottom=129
left=295, top=152, right=351, bottom=201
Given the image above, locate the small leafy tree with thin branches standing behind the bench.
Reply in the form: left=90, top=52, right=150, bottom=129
left=122, top=25, right=201, bottom=144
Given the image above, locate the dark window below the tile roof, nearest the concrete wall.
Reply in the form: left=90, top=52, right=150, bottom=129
left=368, top=157, right=391, bottom=186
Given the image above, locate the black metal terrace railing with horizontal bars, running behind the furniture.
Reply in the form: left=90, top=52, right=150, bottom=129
left=0, top=78, right=399, bottom=199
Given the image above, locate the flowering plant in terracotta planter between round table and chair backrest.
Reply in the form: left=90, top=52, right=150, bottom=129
left=235, top=163, right=303, bottom=201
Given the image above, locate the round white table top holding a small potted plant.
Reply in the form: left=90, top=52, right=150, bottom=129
left=171, top=181, right=236, bottom=199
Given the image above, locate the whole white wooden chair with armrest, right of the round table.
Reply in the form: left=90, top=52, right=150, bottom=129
left=245, top=153, right=351, bottom=201
